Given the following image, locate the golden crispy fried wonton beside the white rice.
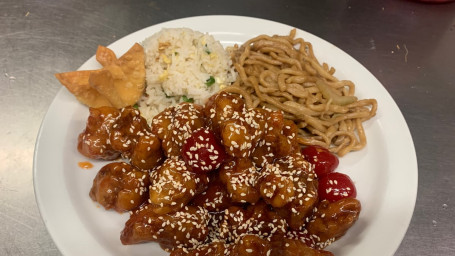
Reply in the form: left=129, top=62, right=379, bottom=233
left=55, top=43, right=145, bottom=108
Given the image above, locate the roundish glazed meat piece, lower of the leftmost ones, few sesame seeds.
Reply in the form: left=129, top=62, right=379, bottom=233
left=90, top=162, right=149, bottom=212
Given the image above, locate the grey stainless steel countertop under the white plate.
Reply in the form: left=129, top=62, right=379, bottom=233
left=0, top=0, right=455, bottom=255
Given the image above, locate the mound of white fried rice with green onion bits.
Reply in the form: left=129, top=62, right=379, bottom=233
left=138, top=28, right=236, bottom=122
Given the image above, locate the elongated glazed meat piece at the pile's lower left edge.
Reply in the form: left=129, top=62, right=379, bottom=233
left=120, top=205, right=209, bottom=250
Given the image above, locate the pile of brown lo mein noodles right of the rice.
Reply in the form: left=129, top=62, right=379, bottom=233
left=224, top=29, right=377, bottom=156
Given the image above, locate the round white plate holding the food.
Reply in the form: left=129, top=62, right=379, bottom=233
left=34, top=16, right=417, bottom=256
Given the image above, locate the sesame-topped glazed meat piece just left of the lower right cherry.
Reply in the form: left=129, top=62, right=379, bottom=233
left=258, top=153, right=318, bottom=229
